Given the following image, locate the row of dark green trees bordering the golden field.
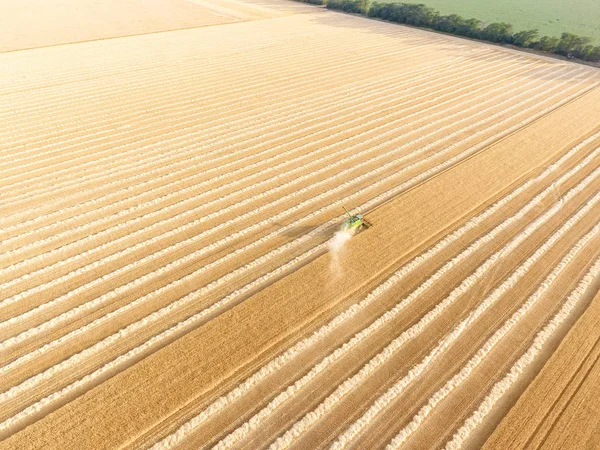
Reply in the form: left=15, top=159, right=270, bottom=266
left=301, top=0, right=600, bottom=62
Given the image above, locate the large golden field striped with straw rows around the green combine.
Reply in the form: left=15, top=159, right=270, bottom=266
left=0, top=0, right=600, bottom=450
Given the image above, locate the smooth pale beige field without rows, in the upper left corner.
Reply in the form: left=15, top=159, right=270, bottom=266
left=0, top=0, right=279, bottom=52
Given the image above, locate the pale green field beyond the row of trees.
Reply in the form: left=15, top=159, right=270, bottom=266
left=384, top=0, right=600, bottom=43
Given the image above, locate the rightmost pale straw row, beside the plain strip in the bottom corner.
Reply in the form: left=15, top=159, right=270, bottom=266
left=445, top=255, right=600, bottom=450
